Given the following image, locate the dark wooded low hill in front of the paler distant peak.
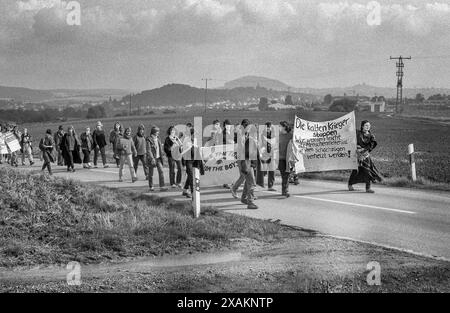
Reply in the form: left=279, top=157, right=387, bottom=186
left=123, top=84, right=314, bottom=107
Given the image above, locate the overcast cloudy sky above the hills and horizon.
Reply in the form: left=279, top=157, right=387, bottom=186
left=0, top=0, right=450, bottom=90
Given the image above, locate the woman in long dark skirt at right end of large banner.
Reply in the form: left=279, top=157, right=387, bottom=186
left=348, top=120, right=382, bottom=193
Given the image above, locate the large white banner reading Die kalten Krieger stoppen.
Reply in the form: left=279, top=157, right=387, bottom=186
left=293, top=112, right=358, bottom=173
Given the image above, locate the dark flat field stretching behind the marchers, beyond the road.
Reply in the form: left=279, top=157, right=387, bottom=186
left=22, top=111, right=450, bottom=184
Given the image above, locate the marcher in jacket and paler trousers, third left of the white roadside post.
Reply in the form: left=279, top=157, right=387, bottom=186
left=147, top=126, right=168, bottom=191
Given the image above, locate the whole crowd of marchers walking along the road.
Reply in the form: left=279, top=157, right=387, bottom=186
left=0, top=119, right=380, bottom=209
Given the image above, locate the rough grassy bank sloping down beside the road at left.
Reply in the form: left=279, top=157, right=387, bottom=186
left=0, top=167, right=298, bottom=267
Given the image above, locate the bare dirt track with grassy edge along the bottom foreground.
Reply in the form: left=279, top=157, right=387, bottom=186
left=0, top=236, right=450, bottom=292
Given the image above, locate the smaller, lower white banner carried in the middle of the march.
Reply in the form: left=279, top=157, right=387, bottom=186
left=200, top=144, right=239, bottom=187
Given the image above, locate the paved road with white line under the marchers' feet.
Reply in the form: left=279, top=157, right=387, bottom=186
left=14, top=161, right=450, bottom=259
